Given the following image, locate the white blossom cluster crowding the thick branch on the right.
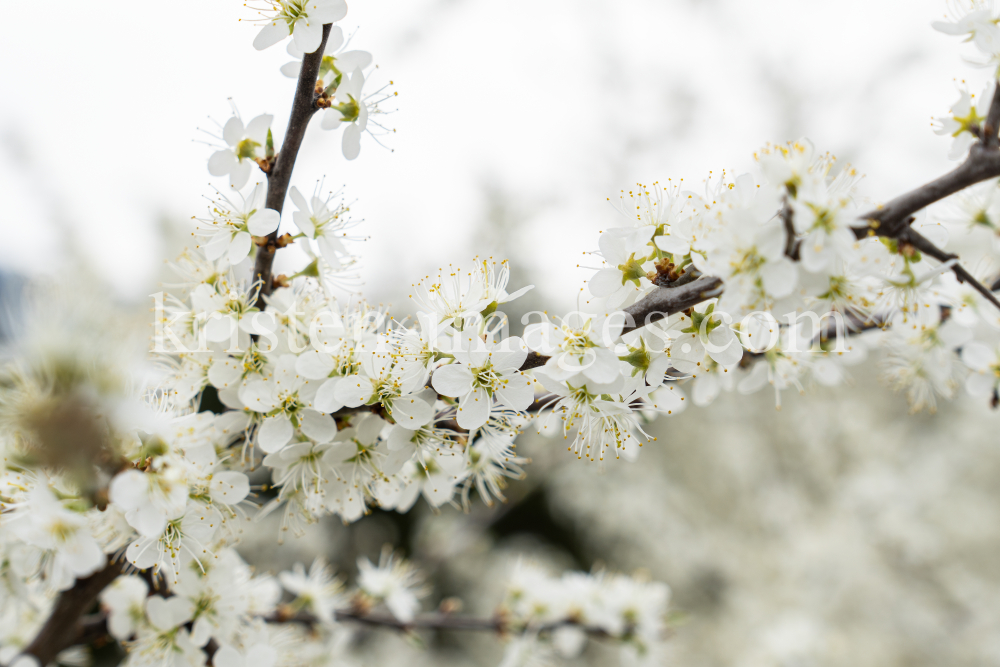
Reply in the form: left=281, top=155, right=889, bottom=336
left=576, top=122, right=1000, bottom=412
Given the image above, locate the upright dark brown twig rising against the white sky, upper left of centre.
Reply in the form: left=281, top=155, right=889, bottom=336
left=253, top=25, right=330, bottom=308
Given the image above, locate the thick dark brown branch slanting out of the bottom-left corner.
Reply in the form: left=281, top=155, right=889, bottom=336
left=24, top=563, right=122, bottom=665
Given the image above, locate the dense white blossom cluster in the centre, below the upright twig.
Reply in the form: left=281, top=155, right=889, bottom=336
left=158, top=253, right=534, bottom=532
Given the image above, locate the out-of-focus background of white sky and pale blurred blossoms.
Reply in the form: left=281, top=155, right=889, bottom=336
left=0, top=0, right=1000, bottom=667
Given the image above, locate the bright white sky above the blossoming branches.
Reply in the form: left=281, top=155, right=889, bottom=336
left=0, top=0, right=987, bottom=308
